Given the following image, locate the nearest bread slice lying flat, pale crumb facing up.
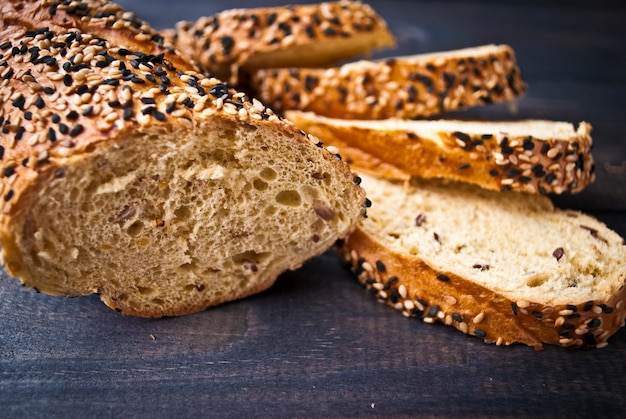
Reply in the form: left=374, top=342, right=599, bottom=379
left=338, top=175, right=626, bottom=348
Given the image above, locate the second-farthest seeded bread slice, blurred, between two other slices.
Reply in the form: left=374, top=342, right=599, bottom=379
left=251, top=45, right=526, bottom=119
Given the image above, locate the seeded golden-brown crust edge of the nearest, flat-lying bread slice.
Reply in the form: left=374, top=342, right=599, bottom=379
left=336, top=227, right=626, bottom=349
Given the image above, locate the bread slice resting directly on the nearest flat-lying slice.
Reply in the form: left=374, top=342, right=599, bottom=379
left=285, top=111, right=595, bottom=194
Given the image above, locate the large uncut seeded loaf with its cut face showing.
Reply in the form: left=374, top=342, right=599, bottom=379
left=0, top=1, right=365, bottom=317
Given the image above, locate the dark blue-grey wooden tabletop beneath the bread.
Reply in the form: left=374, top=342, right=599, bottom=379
left=0, top=0, right=626, bottom=417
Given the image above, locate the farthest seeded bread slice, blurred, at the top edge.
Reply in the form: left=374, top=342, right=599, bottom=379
left=164, top=0, right=395, bottom=83
